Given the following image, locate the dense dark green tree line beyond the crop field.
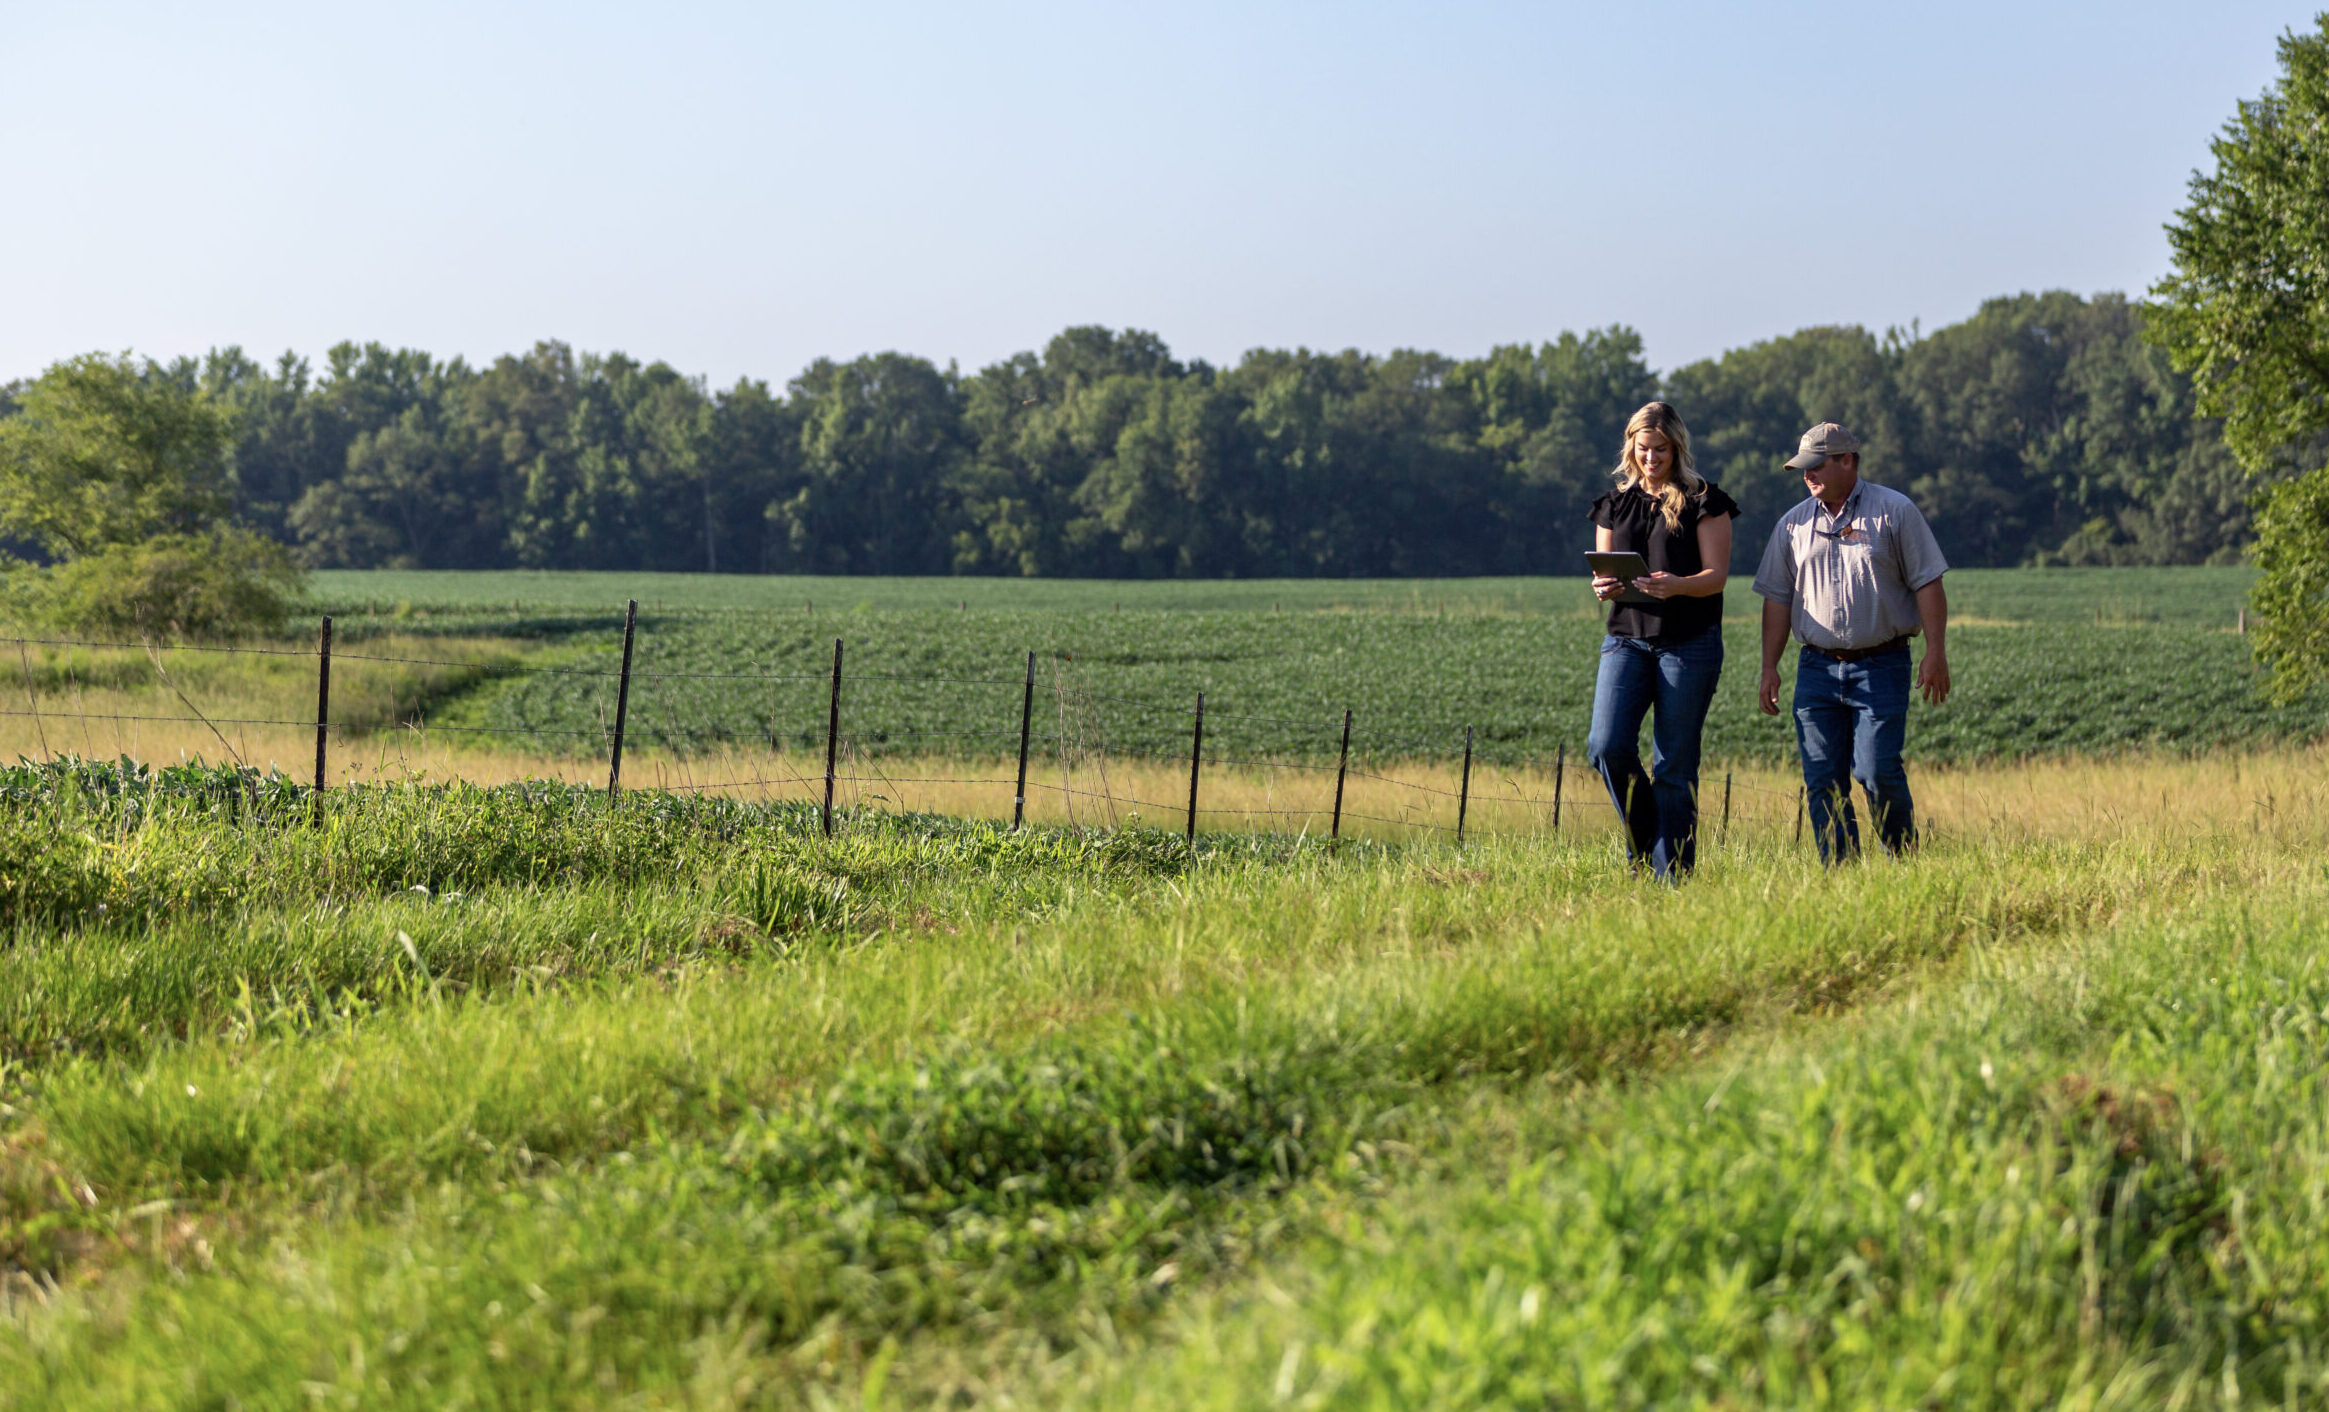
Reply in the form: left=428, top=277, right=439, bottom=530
left=0, top=294, right=2252, bottom=578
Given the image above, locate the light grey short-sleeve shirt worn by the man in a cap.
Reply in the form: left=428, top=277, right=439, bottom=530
left=1754, top=480, right=1949, bottom=650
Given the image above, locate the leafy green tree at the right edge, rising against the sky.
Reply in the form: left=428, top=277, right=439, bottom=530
left=2150, top=14, right=2329, bottom=697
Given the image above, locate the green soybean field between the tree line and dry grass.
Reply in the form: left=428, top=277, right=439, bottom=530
left=305, top=569, right=2329, bottom=764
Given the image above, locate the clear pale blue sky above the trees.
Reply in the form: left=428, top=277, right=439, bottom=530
left=0, top=0, right=2313, bottom=382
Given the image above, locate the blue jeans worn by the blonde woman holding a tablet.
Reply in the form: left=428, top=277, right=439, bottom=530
left=1586, top=627, right=1723, bottom=881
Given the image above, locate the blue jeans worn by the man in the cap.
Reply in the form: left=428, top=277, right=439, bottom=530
left=1796, top=643, right=1917, bottom=862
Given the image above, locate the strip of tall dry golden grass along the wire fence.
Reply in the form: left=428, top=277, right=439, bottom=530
left=0, top=675, right=2329, bottom=846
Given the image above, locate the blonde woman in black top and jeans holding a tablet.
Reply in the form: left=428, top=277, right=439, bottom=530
left=1586, top=403, right=1740, bottom=881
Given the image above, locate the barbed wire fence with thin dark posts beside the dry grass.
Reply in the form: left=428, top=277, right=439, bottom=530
left=0, top=601, right=1805, bottom=846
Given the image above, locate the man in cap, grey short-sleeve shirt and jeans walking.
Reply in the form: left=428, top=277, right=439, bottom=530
left=1754, top=422, right=1949, bottom=862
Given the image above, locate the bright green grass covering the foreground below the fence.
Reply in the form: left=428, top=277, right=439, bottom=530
left=0, top=757, right=2329, bottom=1407
